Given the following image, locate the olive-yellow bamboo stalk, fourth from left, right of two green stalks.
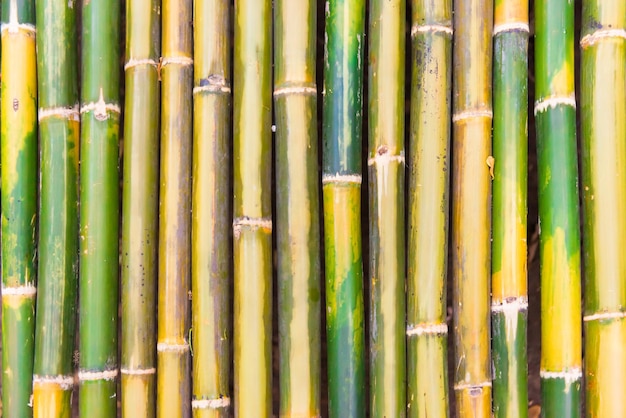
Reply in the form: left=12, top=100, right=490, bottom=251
left=120, top=0, right=161, bottom=418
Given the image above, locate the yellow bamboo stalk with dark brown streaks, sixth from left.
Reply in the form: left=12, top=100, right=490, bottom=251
left=191, top=0, right=232, bottom=418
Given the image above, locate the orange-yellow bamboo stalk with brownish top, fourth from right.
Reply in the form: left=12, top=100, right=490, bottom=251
left=451, top=0, right=493, bottom=418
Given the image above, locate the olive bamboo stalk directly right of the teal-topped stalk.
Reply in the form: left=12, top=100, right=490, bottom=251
left=367, top=0, right=406, bottom=417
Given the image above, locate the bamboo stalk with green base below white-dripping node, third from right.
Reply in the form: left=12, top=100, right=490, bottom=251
left=491, top=0, right=529, bottom=418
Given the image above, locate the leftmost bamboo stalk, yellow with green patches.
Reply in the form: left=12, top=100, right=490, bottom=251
left=0, top=0, right=38, bottom=417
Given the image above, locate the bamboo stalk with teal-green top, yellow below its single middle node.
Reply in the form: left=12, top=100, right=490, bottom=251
left=322, top=0, right=366, bottom=418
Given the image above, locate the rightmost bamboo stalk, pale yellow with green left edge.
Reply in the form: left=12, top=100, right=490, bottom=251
left=580, top=0, right=626, bottom=417
